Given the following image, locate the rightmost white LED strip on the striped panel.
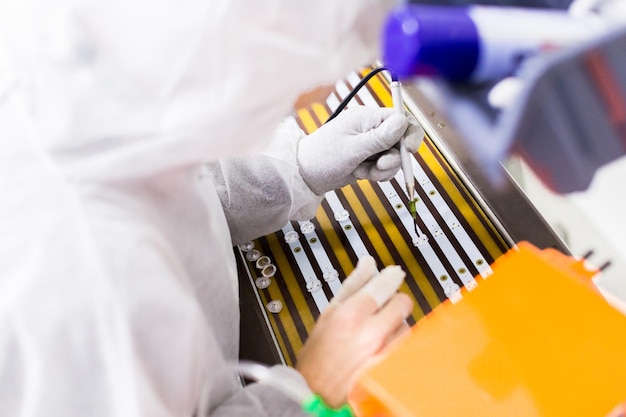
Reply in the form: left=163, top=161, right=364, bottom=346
left=412, top=158, right=492, bottom=276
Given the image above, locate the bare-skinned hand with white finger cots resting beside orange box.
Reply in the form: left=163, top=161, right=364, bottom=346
left=296, top=256, right=413, bottom=407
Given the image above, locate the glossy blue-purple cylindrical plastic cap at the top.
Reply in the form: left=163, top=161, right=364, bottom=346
left=382, top=5, right=480, bottom=81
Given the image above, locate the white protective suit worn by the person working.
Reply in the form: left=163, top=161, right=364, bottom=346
left=0, top=0, right=390, bottom=417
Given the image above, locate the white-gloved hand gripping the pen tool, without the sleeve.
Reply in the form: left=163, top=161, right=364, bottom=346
left=297, top=106, right=424, bottom=195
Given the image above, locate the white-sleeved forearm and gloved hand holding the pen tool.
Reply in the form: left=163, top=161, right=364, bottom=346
left=206, top=106, right=424, bottom=244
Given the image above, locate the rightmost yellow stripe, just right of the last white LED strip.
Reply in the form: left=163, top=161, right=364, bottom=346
left=419, top=138, right=502, bottom=259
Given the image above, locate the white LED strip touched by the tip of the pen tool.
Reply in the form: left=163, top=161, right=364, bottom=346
left=378, top=181, right=460, bottom=297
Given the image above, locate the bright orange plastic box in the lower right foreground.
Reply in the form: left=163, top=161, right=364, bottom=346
left=349, top=242, right=626, bottom=417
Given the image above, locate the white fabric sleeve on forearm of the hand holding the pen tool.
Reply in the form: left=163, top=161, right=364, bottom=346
left=206, top=119, right=323, bottom=244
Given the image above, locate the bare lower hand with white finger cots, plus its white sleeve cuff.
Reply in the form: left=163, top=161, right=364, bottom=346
left=210, top=256, right=413, bottom=417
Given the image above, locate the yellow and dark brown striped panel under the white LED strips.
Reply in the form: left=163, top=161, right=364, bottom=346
left=235, top=69, right=509, bottom=365
